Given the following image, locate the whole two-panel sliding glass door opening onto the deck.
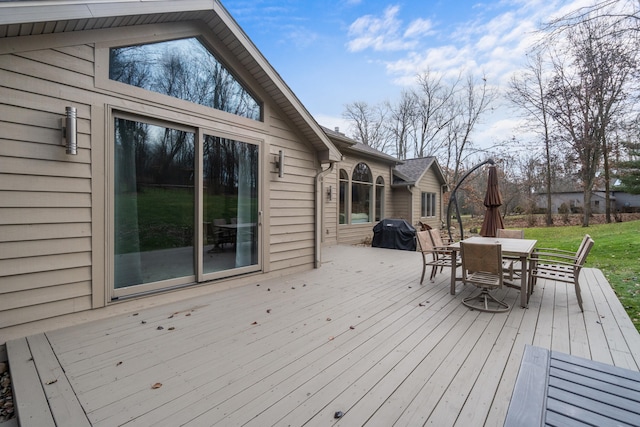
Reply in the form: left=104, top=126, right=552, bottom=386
left=113, top=115, right=259, bottom=297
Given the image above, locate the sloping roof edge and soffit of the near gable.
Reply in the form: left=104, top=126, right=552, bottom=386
left=0, top=0, right=341, bottom=162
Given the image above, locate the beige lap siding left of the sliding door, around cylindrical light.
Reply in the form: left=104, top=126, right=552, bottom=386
left=0, top=45, right=93, bottom=327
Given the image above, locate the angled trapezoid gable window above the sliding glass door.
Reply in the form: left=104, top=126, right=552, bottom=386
left=109, top=37, right=262, bottom=120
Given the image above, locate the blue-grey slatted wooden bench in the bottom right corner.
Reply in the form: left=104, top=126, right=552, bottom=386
left=504, top=345, right=640, bottom=427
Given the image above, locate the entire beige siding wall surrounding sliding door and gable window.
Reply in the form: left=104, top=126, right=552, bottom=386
left=0, top=24, right=327, bottom=328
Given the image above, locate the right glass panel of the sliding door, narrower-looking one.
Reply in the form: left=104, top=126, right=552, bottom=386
left=202, top=135, right=259, bottom=274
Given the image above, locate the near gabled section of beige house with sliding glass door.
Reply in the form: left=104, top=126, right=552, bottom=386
left=0, top=0, right=342, bottom=334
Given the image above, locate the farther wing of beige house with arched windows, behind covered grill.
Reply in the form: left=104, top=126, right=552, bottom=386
left=323, top=128, right=447, bottom=244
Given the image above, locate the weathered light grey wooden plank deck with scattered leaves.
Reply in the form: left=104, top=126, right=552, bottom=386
left=7, top=246, right=640, bottom=426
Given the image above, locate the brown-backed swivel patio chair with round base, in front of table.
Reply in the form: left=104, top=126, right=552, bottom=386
left=460, top=240, right=510, bottom=313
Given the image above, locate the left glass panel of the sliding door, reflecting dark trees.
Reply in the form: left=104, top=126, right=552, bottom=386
left=114, top=118, right=195, bottom=289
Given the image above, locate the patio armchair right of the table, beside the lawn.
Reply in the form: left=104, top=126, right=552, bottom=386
left=529, top=234, right=594, bottom=311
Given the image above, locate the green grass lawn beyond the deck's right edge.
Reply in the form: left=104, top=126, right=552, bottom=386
left=525, top=221, right=640, bottom=331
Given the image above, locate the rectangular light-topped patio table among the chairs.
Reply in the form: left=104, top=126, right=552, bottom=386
left=448, top=236, right=538, bottom=308
